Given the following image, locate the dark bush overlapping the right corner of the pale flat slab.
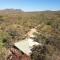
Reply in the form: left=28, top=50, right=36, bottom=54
left=31, top=45, right=46, bottom=60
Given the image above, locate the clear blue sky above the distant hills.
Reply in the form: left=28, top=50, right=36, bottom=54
left=0, top=0, right=60, bottom=11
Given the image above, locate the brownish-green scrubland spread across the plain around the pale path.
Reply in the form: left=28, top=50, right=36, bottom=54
left=0, top=12, right=60, bottom=60
